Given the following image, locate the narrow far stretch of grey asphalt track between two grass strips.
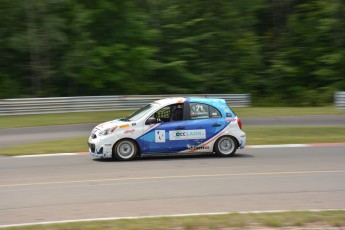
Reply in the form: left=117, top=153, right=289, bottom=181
left=0, top=115, right=345, bottom=147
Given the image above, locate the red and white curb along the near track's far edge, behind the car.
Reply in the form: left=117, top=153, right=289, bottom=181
left=13, top=142, right=345, bottom=158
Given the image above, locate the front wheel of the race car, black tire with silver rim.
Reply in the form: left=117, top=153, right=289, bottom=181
left=113, top=139, right=138, bottom=161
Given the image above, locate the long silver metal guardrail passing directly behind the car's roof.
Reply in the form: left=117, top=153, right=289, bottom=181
left=0, top=94, right=251, bottom=116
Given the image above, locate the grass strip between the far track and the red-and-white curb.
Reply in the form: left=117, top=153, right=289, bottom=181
left=0, top=126, right=345, bottom=156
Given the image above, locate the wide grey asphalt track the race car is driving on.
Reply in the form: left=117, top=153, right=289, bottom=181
left=0, top=146, right=345, bottom=225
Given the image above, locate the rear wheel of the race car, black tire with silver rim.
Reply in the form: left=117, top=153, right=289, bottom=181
left=214, top=136, right=238, bottom=157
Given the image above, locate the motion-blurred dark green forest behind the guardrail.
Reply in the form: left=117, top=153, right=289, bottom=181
left=0, top=0, right=345, bottom=106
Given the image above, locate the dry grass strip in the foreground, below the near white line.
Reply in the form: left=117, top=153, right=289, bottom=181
left=5, top=210, right=345, bottom=230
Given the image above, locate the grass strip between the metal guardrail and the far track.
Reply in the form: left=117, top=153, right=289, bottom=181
left=0, top=106, right=345, bottom=129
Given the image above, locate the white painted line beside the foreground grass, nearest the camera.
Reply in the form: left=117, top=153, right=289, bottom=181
left=0, top=209, right=345, bottom=228
